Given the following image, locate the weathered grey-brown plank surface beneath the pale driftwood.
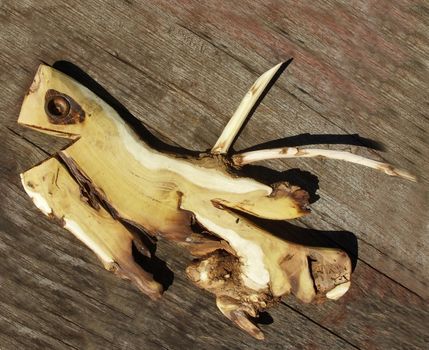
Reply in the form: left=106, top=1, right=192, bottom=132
left=0, top=0, right=429, bottom=350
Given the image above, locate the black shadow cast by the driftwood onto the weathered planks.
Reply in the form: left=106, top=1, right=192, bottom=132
left=53, top=60, right=358, bottom=290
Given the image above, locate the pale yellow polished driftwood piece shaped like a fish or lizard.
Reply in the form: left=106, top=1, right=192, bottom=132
left=18, top=62, right=415, bottom=339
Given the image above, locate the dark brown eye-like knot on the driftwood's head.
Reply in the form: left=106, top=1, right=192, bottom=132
left=45, top=89, right=85, bottom=124
